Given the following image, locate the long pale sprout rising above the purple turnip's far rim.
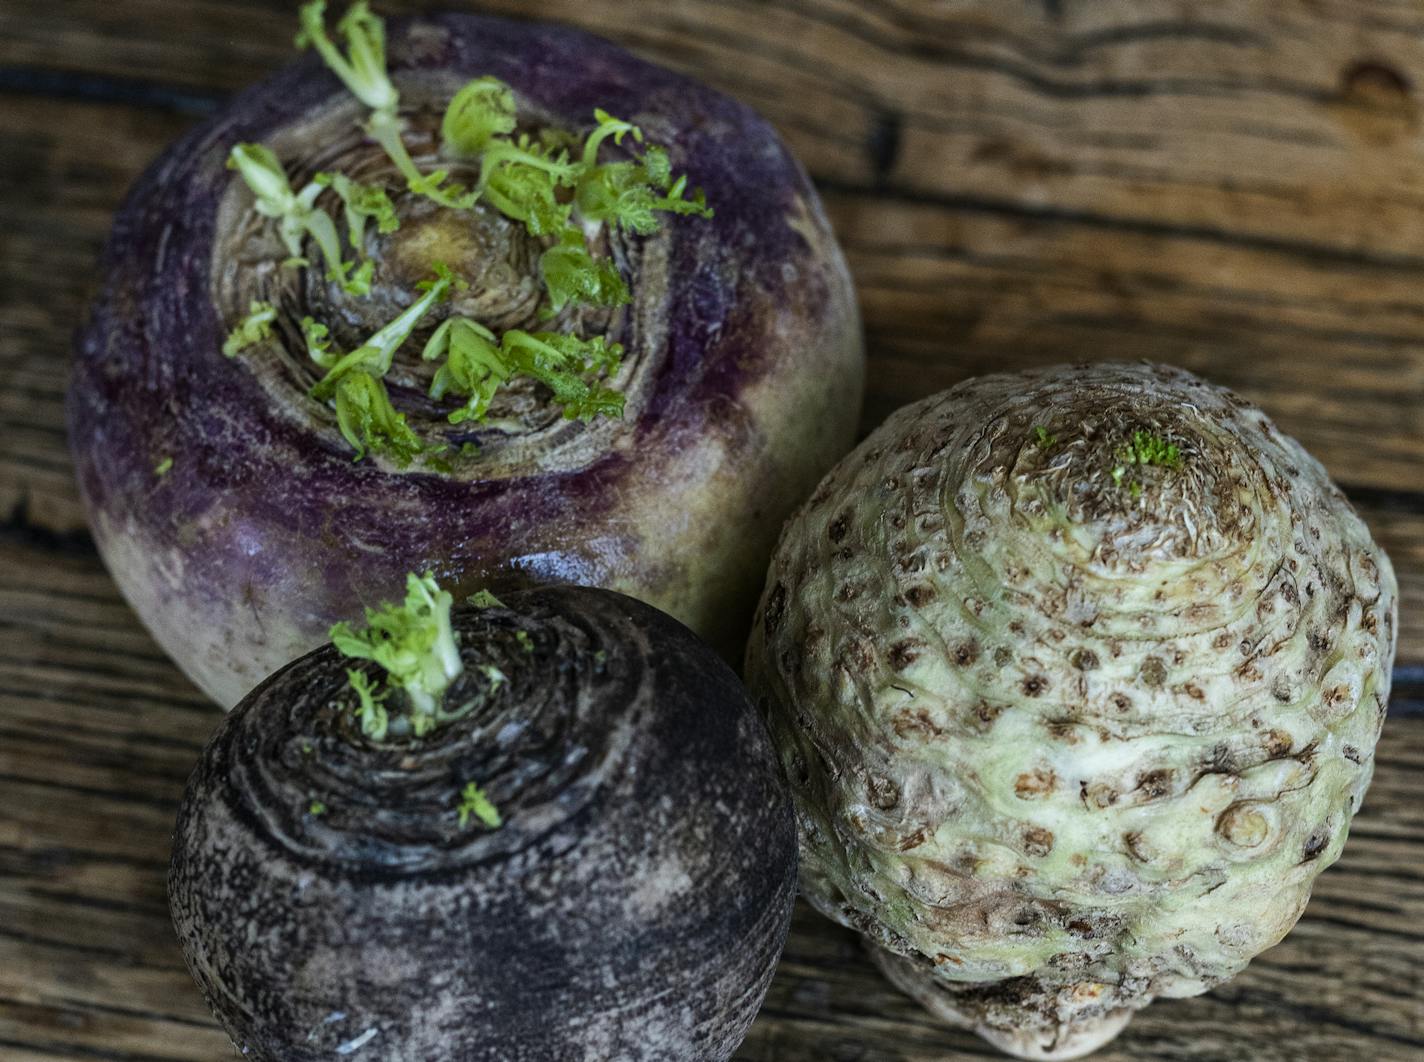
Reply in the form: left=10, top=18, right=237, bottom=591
left=296, top=0, right=478, bottom=209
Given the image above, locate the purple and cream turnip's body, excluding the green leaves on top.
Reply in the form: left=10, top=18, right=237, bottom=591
left=68, top=14, right=864, bottom=706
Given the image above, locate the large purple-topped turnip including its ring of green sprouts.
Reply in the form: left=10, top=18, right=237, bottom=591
left=68, top=3, right=863, bottom=706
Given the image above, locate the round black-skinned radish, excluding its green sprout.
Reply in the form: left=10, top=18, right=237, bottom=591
left=168, top=587, right=796, bottom=1062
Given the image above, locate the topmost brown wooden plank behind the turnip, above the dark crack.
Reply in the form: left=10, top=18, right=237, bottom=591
left=0, top=0, right=1424, bottom=253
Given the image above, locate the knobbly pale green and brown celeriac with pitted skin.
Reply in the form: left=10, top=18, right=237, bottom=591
left=748, top=364, right=1397, bottom=1058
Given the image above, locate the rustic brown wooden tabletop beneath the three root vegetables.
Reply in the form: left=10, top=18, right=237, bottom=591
left=0, top=0, right=1424, bottom=1062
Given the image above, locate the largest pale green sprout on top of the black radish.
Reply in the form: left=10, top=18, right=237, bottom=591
left=330, top=572, right=464, bottom=736
